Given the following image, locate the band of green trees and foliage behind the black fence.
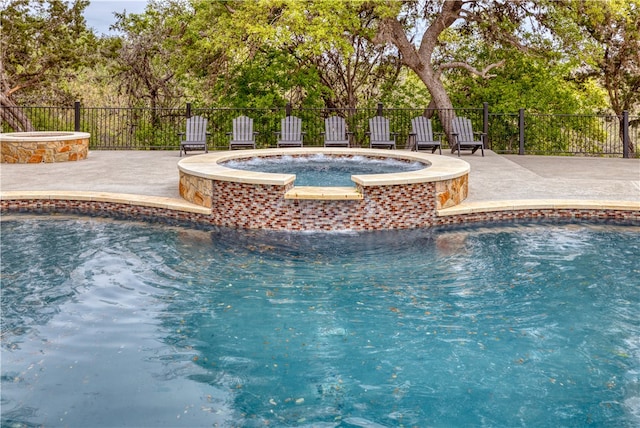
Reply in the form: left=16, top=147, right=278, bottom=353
left=0, top=0, right=640, bottom=155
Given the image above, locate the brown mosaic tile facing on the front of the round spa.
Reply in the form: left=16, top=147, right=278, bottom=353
left=202, top=181, right=436, bottom=230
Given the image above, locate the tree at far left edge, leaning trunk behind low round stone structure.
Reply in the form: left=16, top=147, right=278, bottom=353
left=0, top=0, right=96, bottom=131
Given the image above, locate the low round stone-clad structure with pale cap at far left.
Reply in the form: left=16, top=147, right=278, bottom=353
left=0, top=131, right=91, bottom=163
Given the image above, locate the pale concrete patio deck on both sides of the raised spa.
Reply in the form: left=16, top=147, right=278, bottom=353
left=0, top=151, right=640, bottom=219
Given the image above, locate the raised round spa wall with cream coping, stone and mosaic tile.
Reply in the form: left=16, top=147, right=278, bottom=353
left=178, top=148, right=469, bottom=231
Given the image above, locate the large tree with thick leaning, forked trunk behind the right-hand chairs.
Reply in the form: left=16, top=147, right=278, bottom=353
left=374, top=0, right=564, bottom=150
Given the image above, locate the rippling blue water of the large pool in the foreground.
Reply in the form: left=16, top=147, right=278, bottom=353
left=1, top=216, right=640, bottom=427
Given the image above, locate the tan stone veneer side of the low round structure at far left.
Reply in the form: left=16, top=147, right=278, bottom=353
left=0, top=136, right=89, bottom=163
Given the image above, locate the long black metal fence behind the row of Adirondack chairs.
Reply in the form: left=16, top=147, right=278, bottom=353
left=1, top=103, right=640, bottom=157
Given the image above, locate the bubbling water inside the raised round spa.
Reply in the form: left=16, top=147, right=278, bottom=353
left=223, top=154, right=427, bottom=186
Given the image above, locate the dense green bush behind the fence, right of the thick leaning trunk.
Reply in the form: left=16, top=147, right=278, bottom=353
left=446, top=29, right=606, bottom=153
